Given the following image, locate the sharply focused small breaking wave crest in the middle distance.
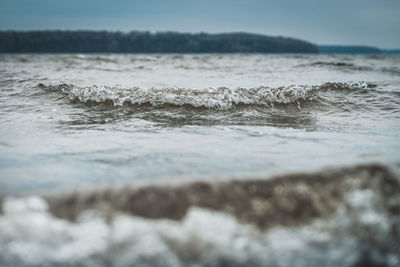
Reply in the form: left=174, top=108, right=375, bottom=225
left=37, top=82, right=376, bottom=110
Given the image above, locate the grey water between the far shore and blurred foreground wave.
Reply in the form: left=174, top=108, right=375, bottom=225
left=0, top=54, right=400, bottom=194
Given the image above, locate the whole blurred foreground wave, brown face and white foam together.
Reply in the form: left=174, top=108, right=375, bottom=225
left=0, top=165, right=400, bottom=267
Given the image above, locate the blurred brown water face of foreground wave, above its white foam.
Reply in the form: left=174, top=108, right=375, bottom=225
left=40, top=165, right=400, bottom=229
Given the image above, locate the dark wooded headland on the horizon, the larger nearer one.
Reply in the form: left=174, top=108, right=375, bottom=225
left=0, top=31, right=318, bottom=53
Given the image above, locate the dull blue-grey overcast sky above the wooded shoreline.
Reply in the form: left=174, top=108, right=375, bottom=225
left=0, top=0, right=400, bottom=49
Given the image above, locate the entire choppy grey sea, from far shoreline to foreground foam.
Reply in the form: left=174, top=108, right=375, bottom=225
left=0, top=54, right=400, bottom=267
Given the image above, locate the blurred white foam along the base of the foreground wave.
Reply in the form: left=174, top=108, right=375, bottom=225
left=0, top=189, right=400, bottom=266
